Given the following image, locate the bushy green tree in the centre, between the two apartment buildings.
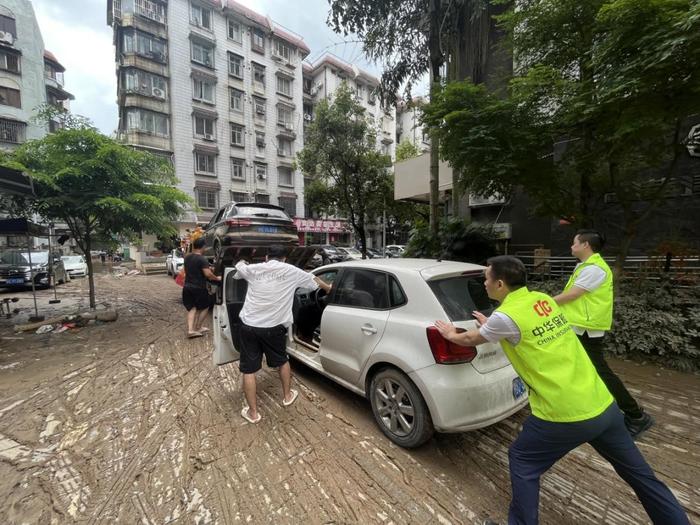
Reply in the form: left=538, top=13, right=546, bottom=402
left=297, top=84, right=391, bottom=257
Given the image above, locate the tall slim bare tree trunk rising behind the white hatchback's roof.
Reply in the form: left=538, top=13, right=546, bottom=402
left=428, top=0, right=443, bottom=237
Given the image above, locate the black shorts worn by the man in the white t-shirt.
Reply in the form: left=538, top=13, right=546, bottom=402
left=239, top=323, right=289, bottom=374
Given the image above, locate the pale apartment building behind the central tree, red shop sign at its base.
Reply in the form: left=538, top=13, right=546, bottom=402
left=297, top=53, right=396, bottom=247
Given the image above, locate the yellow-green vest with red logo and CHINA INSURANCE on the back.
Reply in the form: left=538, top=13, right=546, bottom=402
left=496, top=287, right=613, bottom=423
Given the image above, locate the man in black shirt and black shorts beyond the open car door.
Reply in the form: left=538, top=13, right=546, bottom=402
left=182, top=237, right=221, bottom=338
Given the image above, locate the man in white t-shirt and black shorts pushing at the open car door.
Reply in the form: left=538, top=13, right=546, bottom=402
left=234, top=246, right=331, bottom=423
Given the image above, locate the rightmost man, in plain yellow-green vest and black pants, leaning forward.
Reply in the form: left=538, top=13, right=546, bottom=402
left=554, top=230, right=654, bottom=437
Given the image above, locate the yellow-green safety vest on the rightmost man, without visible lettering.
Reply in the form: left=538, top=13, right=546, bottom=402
left=561, top=253, right=613, bottom=331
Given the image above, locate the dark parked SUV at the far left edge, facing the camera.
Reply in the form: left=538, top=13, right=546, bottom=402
left=0, top=249, right=70, bottom=288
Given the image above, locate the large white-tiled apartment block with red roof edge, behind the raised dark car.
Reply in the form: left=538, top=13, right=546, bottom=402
left=107, top=0, right=309, bottom=232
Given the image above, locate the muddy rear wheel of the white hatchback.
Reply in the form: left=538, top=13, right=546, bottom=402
left=369, top=368, right=434, bottom=448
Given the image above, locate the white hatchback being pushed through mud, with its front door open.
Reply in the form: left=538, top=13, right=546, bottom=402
left=214, top=259, right=528, bottom=447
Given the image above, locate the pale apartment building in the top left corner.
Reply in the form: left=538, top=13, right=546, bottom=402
left=0, top=0, right=73, bottom=150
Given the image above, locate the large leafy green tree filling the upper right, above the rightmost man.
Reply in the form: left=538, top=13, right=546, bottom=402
left=425, top=0, right=700, bottom=270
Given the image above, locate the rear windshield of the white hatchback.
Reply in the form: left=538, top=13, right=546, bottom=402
left=428, top=274, right=495, bottom=321
